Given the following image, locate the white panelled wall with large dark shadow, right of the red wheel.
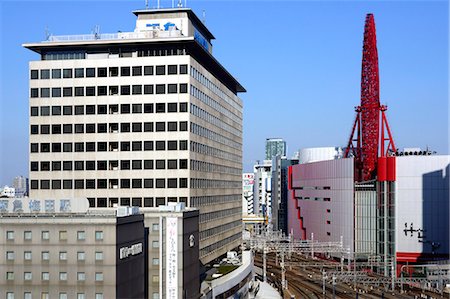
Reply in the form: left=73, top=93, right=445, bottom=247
left=395, top=155, right=450, bottom=254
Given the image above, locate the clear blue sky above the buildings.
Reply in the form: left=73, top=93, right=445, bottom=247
left=0, top=0, right=449, bottom=185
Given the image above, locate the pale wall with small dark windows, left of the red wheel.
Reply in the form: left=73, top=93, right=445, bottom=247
left=288, top=159, right=354, bottom=254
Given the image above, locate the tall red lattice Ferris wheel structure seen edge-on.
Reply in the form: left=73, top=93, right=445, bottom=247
left=345, top=14, right=395, bottom=181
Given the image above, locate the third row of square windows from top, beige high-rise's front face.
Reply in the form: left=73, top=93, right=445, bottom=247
left=30, top=102, right=188, bottom=116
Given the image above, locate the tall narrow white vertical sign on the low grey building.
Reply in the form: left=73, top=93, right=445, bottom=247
left=166, top=217, right=178, bottom=299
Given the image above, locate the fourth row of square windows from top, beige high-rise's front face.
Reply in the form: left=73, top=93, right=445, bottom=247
left=30, top=121, right=187, bottom=135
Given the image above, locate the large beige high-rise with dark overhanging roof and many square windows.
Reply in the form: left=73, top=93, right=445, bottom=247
left=24, top=8, right=245, bottom=262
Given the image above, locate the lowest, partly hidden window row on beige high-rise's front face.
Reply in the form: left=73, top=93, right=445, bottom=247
left=88, top=197, right=188, bottom=209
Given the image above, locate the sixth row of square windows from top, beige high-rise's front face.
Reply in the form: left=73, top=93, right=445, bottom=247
left=30, top=159, right=188, bottom=171
